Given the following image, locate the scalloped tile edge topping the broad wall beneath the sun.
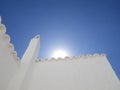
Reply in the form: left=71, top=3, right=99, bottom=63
left=36, top=53, right=106, bottom=62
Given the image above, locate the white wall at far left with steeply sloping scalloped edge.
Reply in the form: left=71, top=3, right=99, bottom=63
left=0, top=24, right=20, bottom=90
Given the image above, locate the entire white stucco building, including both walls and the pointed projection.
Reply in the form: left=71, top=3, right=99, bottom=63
left=0, top=17, right=120, bottom=90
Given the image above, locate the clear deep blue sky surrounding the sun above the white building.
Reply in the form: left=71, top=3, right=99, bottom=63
left=0, top=0, right=120, bottom=79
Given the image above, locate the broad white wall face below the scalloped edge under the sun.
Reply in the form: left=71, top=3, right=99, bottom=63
left=20, top=56, right=120, bottom=90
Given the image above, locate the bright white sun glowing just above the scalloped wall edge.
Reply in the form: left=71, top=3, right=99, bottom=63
left=52, top=50, right=68, bottom=58
